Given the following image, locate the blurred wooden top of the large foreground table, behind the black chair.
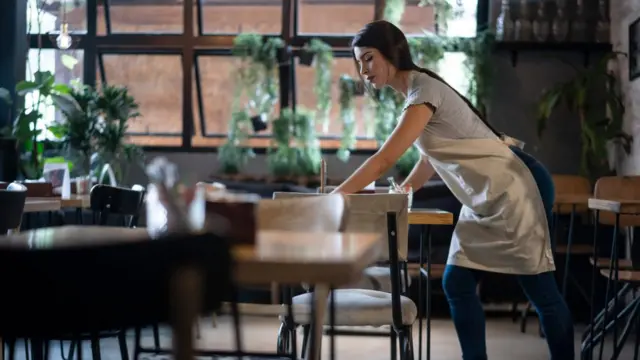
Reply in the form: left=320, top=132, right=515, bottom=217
left=0, top=226, right=382, bottom=286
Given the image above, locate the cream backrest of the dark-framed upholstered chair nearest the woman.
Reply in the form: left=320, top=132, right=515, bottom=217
left=278, top=192, right=409, bottom=261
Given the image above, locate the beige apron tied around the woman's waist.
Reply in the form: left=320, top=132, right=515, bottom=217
left=416, top=131, right=555, bottom=274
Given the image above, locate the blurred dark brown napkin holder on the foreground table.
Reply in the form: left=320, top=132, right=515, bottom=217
left=205, top=192, right=260, bottom=245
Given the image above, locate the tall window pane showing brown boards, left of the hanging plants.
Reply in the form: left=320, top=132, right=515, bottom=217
left=101, top=54, right=182, bottom=136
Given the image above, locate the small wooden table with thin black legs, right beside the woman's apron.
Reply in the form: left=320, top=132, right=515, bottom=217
left=409, top=209, right=454, bottom=360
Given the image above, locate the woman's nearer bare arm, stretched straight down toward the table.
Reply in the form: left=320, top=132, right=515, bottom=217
left=333, top=104, right=433, bottom=194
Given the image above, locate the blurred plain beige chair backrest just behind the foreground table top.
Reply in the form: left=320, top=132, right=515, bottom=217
left=257, top=192, right=348, bottom=232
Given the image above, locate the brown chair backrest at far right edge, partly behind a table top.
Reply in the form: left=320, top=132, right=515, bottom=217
left=594, top=176, right=640, bottom=227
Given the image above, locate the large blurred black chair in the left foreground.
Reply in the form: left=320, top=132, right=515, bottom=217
left=0, top=234, right=239, bottom=360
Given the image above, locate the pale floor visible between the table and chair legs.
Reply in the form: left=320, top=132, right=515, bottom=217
left=7, top=317, right=633, bottom=360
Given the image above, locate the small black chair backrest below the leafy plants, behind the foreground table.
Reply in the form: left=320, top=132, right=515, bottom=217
left=90, top=184, right=145, bottom=226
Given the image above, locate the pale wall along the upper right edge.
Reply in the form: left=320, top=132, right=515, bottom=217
left=611, top=0, right=640, bottom=175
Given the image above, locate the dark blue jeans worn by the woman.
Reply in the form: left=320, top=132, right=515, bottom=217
left=442, top=148, right=575, bottom=360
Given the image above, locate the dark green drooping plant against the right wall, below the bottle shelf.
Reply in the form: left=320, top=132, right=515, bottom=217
left=536, top=52, right=633, bottom=181
